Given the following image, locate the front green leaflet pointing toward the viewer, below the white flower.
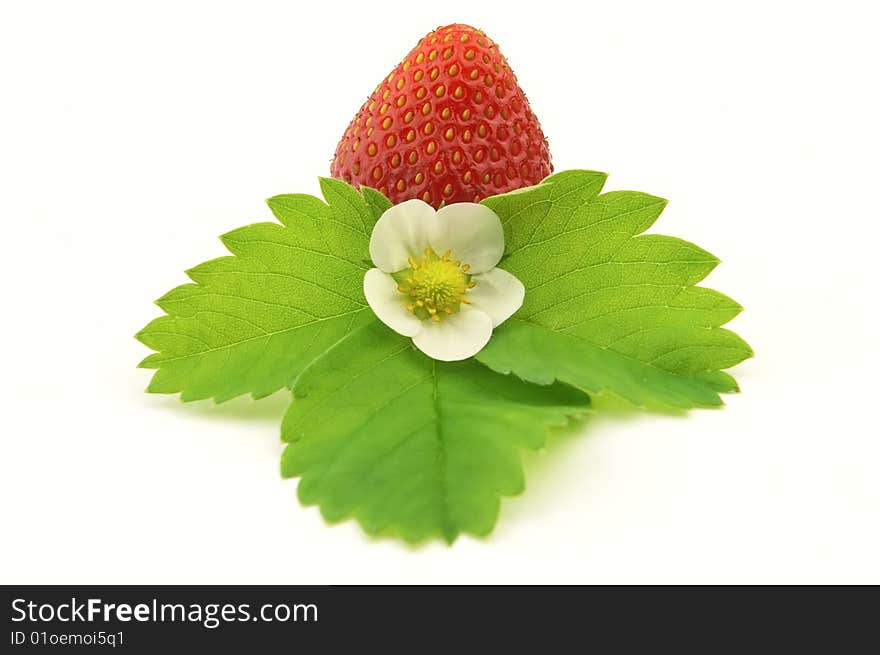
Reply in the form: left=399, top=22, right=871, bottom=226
left=282, top=321, right=589, bottom=542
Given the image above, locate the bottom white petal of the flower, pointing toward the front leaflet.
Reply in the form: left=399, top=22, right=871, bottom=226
left=413, top=307, right=492, bottom=362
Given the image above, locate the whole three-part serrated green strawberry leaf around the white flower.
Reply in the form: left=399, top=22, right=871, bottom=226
left=137, top=171, right=752, bottom=542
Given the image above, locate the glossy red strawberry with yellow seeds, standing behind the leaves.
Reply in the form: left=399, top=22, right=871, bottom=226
left=330, top=24, right=553, bottom=207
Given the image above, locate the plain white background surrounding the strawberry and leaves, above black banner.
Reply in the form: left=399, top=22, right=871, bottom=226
left=0, top=0, right=880, bottom=583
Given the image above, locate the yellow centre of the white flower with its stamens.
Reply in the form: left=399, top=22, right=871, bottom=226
left=394, top=248, right=477, bottom=321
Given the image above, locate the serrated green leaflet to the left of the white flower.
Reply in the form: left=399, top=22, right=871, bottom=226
left=137, top=179, right=388, bottom=402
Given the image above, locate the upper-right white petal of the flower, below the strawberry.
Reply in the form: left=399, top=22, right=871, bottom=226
left=428, top=202, right=504, bottom=273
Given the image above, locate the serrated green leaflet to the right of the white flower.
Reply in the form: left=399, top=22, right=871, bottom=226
left=477, top=171, right=752, bottom=407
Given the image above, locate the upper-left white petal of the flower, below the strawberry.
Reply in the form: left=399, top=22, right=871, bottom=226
left=370, top=200, right=437, bottom=273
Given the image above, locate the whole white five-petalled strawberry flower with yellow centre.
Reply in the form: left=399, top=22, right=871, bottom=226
left=364, top=200, right=525, bottom=361
